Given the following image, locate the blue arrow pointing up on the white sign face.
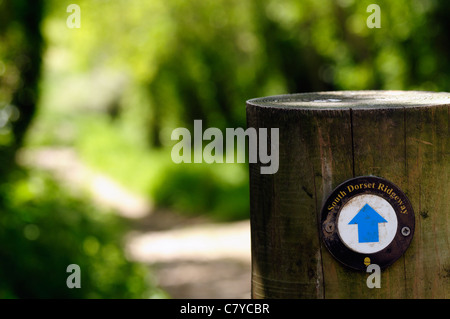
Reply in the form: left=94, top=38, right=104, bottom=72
left=348, top=204, right=388, bottom=243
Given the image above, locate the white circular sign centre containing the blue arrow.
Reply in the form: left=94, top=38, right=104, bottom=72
left=337, top=194, right=398, bottom=254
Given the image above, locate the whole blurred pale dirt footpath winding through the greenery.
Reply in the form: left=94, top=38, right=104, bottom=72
left=18, top=148, right=251, bottom=299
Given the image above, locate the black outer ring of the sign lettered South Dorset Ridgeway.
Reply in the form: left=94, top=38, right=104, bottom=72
left=321, top=176, right=415, bottom=271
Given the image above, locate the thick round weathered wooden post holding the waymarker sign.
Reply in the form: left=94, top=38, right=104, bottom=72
left=247, top=91, right=450, bottom=298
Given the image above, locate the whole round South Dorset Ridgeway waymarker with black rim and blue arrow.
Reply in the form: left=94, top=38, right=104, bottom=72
left=322, top=176, right=414, bottom=270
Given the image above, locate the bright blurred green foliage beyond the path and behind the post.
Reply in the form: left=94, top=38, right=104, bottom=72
left=35, top=0, right=450, bottom=218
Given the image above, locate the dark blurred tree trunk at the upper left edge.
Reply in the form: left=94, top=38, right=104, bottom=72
left=0, top=0, right=44, bottom=181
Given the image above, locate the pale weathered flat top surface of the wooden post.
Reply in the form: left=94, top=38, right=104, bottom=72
left=247, top=91, right=450, bottom=110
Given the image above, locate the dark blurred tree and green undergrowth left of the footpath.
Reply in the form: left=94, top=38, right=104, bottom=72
left=0, top=0, right=159, bottom=298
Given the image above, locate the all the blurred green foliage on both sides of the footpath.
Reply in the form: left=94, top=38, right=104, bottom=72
left=0, top=0, right=450, bottom=297
